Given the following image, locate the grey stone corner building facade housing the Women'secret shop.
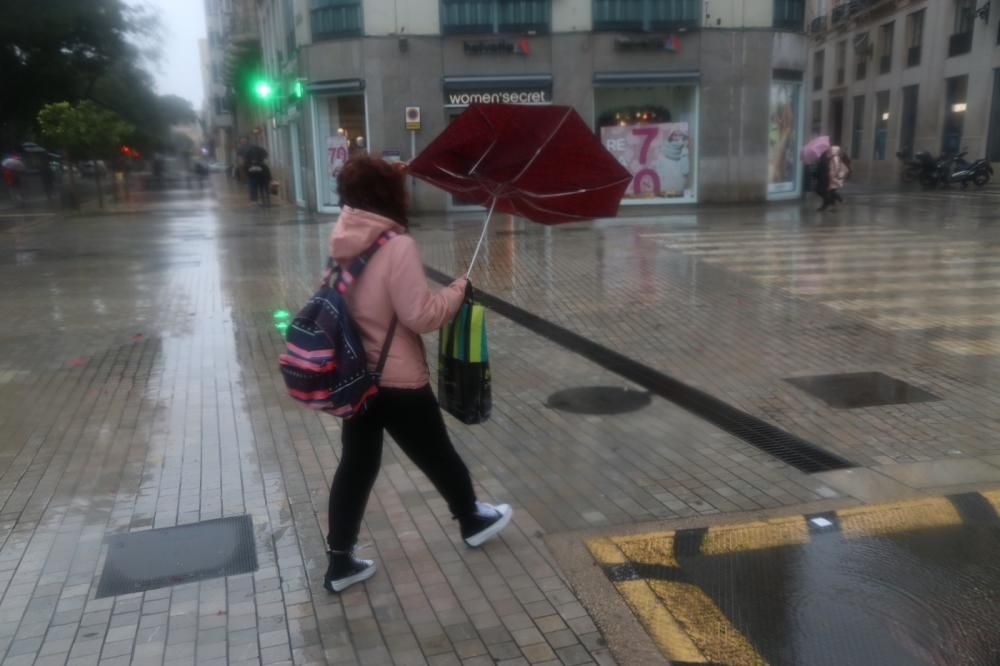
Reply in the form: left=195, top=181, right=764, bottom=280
left=250, top=0, right=809, bottom=212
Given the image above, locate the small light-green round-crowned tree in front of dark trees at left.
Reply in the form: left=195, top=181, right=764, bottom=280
left=38, top=101, right=135, bottom=208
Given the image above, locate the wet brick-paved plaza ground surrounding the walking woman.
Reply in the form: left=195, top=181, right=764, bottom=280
left=0, top=182, right=1000, bottom=665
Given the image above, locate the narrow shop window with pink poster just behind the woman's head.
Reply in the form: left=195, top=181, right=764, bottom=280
left=308, top=79, right=369, bottom=213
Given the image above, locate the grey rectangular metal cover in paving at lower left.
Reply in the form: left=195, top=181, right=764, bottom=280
left=97, top=515, right=257, bottom=599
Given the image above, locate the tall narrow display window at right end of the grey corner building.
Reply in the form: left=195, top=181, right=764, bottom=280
left=767, top=72, right=804, bottom=201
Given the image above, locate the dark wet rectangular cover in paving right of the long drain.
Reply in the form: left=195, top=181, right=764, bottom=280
left=785, top=372, right=941, bottom=409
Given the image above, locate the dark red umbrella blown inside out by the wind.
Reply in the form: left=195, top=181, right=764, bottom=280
left=409, top=104, right=632, bottom=270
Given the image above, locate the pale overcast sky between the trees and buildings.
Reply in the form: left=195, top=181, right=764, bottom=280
left=137, top=0, right=205, bottom=111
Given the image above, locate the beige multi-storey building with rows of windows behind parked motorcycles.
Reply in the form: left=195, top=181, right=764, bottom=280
left=807, top=0, right=1000, bottom=184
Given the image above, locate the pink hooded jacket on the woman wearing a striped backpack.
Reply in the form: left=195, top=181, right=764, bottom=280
left=330, top=206, right=466, bottom=389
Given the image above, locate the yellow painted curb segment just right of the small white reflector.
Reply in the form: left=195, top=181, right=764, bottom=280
left=837, top=497, right=962, bottom=538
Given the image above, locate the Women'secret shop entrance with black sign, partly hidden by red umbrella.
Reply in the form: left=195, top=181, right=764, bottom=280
left=443, top=74, right=552, bottom=211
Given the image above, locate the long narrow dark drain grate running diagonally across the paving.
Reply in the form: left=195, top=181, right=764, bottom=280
left=425, top=266, right=856, bottom=474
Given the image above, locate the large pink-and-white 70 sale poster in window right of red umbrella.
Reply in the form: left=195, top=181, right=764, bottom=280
left=601, top=122, right=692, bottom=199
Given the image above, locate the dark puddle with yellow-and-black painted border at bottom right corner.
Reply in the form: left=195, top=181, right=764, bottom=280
left=588, top=492, right=1000, bottom=666
